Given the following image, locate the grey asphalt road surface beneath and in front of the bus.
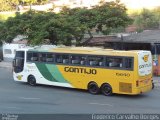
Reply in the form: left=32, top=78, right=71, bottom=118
left=0, top=68, right=160, bottom=114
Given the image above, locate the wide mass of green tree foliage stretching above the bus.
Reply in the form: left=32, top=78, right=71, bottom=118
left=0, top=0, right=132, bottom=45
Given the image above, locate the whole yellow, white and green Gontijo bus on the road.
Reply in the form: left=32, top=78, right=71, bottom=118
left=13, top=47, right=152, bottom=95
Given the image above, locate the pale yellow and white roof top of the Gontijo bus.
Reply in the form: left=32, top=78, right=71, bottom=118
left=25, top=47, right=150, bottom=56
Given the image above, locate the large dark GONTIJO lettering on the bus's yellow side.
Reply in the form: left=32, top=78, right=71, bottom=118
left=64, top=67, right=97, bottom=75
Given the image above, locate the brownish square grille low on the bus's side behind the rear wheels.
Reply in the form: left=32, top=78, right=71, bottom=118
left=119, top=82, right=132, bottom=93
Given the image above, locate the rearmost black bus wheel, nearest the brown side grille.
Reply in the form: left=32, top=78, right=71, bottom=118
left=101, top=83, right=112, bottom=96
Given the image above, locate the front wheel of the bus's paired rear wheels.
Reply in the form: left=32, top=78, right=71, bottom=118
left=88, top=82, right=100, bottom=95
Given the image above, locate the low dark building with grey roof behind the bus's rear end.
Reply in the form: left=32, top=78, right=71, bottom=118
left=82, top=30, right=160, bottom=75
